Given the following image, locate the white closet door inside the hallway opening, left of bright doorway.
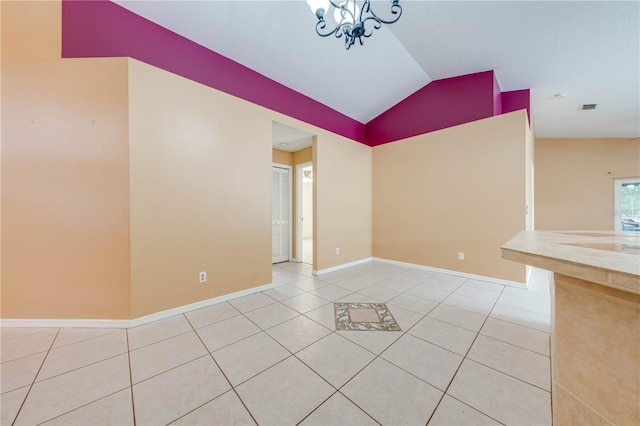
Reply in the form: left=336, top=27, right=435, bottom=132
left=271, top=166, right=291, bottom=263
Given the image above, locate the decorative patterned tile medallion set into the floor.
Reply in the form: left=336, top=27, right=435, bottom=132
left=333, top=303, right=401, bottom=331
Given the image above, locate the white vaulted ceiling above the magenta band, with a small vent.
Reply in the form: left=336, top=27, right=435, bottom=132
left=117, top=0, right=640, bottom=138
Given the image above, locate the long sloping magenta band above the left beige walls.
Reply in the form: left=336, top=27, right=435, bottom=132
left=62, top=0, right=365, bottom=143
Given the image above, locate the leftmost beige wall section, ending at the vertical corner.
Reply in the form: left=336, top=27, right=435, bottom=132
left=0, top=1, right=130, bottom=319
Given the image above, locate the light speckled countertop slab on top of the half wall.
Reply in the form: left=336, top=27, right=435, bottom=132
left=501, top=231, right=640, bottom=294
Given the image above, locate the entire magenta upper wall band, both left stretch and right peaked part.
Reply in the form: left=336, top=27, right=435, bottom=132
left=62, top=0, right=529, bottom=146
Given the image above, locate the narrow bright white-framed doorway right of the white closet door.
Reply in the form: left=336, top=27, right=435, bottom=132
left=296, top=162, right=314, bottom=265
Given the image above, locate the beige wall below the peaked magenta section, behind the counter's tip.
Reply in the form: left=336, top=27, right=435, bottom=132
left=373, top=111, right=527, bottom=282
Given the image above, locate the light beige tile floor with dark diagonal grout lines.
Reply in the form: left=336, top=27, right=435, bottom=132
left=0, top=261, right=551, bottom=426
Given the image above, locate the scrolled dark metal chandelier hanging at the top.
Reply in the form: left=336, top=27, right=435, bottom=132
left=307, top=0, right=402, bottom=50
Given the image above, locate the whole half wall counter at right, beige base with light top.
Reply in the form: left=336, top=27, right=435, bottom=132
left=502, top=231, right=640, bottom=425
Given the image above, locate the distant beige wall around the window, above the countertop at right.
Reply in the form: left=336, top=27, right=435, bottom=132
left=535, top=139, right=640, bottom=231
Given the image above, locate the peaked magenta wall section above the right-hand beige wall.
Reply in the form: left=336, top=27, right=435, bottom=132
left=366, top=71, right=494, bottom=146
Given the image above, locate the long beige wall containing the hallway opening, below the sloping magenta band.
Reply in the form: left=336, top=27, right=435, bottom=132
left=129, top=60, right=371, bottom=317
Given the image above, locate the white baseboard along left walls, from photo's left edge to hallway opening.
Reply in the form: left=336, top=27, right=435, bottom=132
left=0, top=284, right=273, bottom=328
